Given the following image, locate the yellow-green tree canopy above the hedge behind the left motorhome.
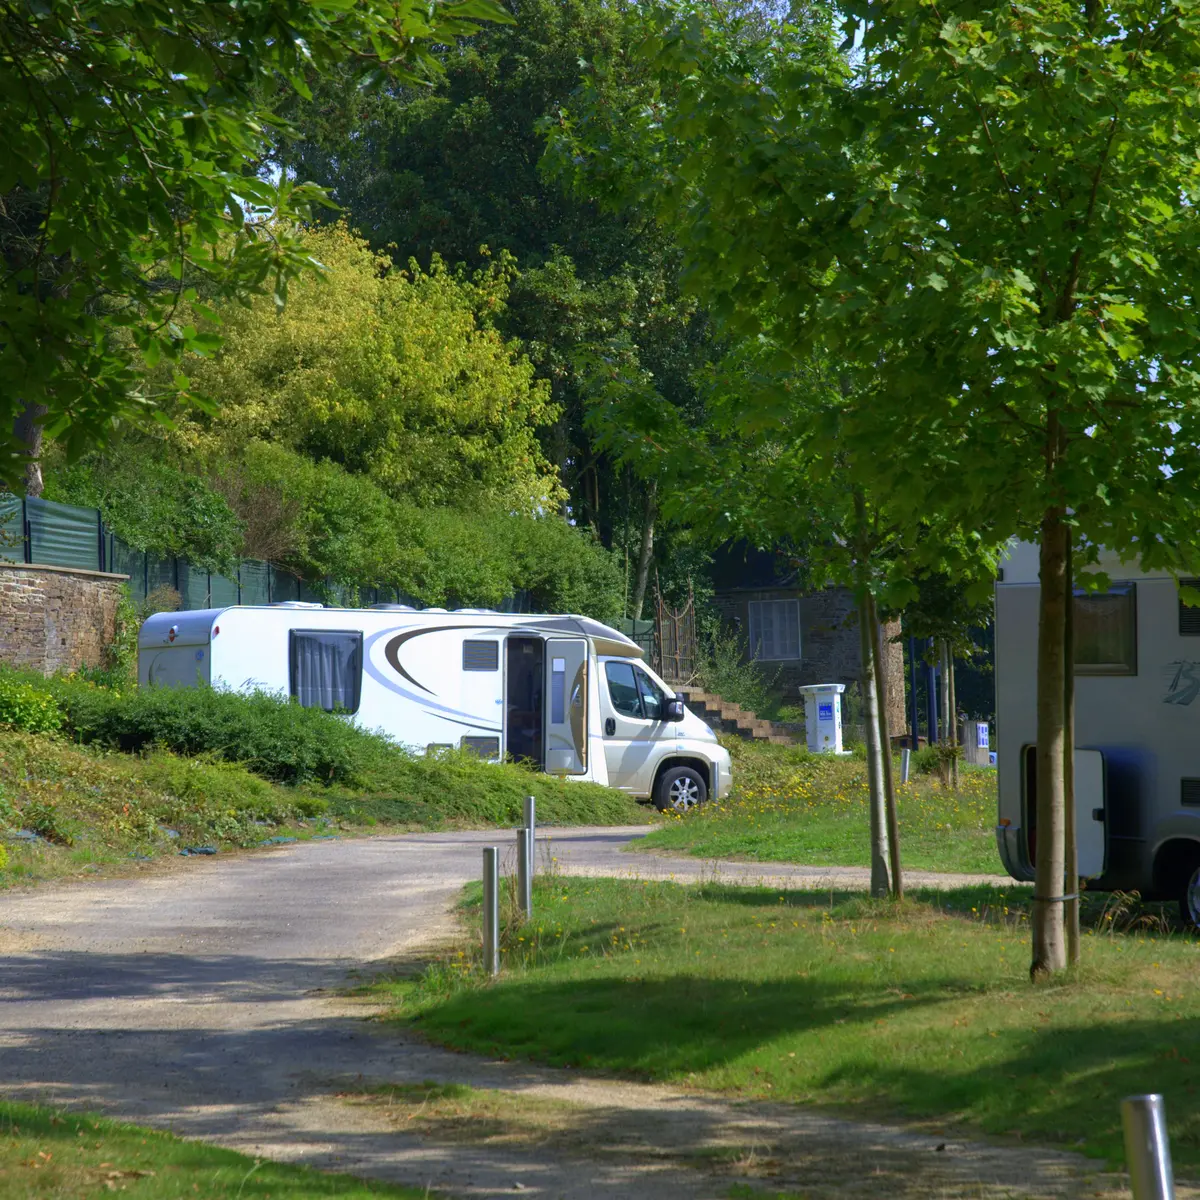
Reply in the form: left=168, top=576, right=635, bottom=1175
left=175, top=224, right=559, bottom=512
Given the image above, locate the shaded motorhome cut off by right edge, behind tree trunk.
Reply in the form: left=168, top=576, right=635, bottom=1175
left=996, top=542, right=1200, bottom=928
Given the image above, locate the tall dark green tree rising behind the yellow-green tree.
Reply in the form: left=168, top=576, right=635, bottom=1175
left=277, top=0, right=712, bottom=580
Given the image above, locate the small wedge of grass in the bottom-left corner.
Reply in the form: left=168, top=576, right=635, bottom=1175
left=0, top=1100, right=427, bottom=1200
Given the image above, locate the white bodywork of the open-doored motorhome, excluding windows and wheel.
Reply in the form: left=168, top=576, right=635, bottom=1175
left=138, top=605, right=731, bottom=797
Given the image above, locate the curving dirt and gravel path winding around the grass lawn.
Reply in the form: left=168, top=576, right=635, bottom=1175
left=0, top=828, right=1161, bottom=1200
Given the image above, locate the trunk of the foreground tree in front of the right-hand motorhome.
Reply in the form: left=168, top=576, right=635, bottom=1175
left=1030, top=508, right=1068, bottom=978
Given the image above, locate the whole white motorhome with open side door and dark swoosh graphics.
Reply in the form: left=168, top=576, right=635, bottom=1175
left=138, top=601, right=732, bottom=810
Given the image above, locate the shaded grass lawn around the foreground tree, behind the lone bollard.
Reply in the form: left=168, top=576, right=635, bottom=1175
left=373, top=876, right=1200, bottom=1175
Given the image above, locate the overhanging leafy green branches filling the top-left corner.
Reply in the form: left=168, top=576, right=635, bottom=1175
left=0, top=0, right=508, bottom=491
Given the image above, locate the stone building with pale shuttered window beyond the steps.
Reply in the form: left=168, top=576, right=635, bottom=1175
left=713, top=544, right=907, bottom=737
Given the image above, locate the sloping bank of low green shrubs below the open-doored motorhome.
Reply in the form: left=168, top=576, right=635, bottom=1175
left=0, top=668, right=649, bottom=886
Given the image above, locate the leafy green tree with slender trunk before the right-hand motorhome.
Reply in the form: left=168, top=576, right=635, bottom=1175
left=552, top=0, right=1200, bottom=976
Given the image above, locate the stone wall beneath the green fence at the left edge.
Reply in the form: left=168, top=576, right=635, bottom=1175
left=0, top=562, right=128, bottom=674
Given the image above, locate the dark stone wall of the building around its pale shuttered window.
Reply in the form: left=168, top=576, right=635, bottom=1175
left=713, top=588, right=907, bottom=737
